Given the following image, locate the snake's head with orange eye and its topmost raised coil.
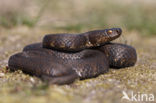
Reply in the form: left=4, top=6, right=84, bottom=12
left=43, top=28, right=122, bottom=51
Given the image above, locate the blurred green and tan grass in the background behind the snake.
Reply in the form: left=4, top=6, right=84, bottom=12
left=0, top=0, right=156, bottom=35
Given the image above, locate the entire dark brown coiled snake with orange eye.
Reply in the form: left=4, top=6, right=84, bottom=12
left=8, top=28, right=137, bottom=84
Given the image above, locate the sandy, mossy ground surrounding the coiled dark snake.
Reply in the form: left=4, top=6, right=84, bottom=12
left=0, top=27, right=156, bottom=103
